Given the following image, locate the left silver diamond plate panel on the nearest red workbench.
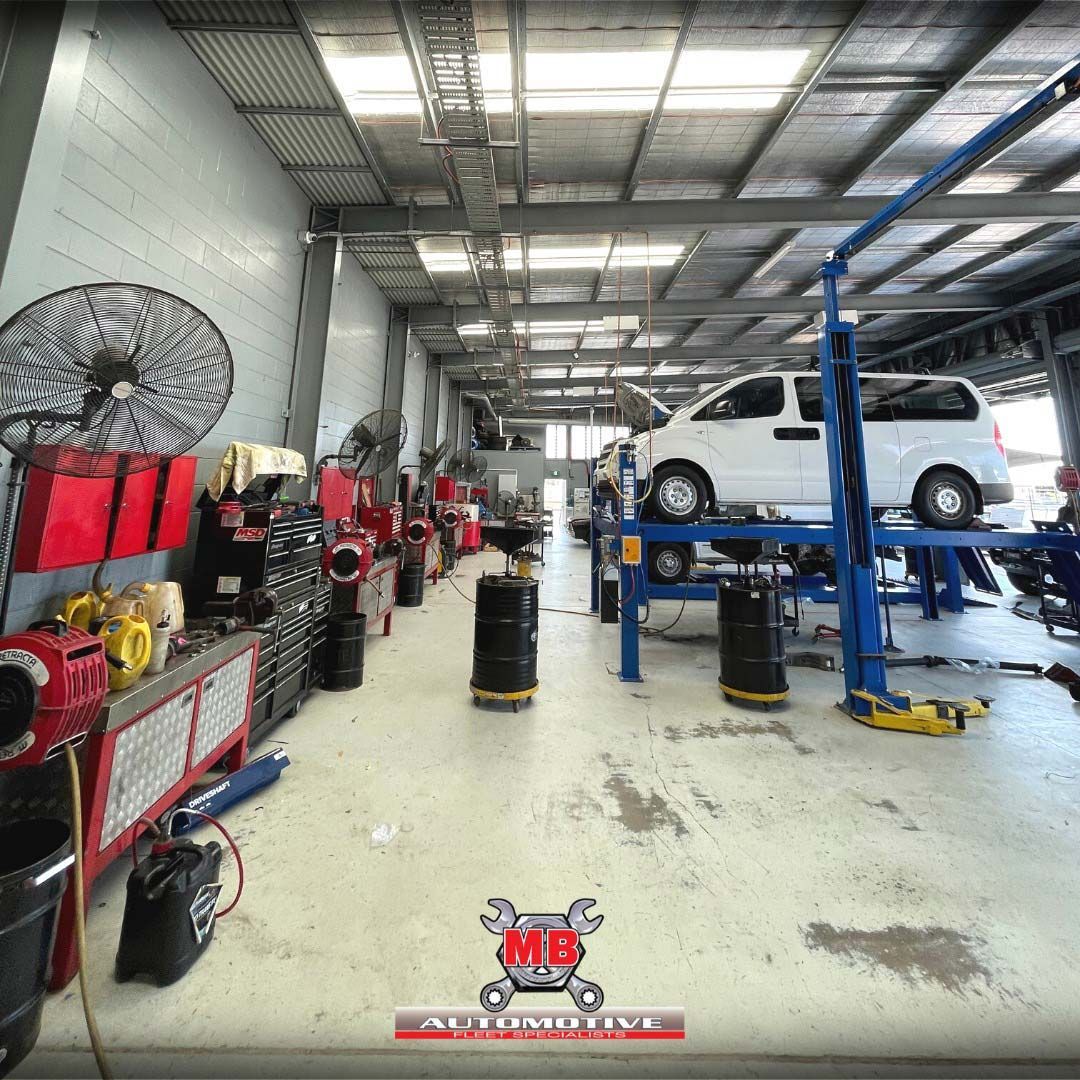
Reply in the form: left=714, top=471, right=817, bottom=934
left=98, top=687, right=195, bottom=851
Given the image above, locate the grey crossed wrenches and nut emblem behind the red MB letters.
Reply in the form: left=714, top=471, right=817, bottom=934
left=480, top=900, right=604, bottom=1012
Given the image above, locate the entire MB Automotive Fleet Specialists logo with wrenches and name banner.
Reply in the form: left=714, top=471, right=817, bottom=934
left=394, top=900, right=686, bottom=1040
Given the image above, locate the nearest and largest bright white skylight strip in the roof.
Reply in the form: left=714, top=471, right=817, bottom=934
left=326, top=49, right=809, bottom=117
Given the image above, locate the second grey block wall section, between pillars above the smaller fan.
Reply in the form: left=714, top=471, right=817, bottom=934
left=316, top=254, right=390, bottom=470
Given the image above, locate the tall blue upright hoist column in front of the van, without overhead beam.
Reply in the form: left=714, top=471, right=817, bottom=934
left=818, top=259, right=899, bottom=713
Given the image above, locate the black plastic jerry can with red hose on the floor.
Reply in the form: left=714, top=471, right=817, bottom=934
left=116, top=840, right=221, bottom=986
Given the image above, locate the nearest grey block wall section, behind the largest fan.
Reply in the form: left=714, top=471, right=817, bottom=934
left=9, top=3, right=309, bottom=627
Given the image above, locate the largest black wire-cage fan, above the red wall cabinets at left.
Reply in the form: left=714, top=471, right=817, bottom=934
left=0, top=283, right=232, bottom=476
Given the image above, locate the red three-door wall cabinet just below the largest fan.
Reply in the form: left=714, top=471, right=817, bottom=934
left=15, top=457, right=198, bottom=573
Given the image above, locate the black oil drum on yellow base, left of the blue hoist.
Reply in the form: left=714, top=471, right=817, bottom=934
left=470, top=573, right=540, bottom=700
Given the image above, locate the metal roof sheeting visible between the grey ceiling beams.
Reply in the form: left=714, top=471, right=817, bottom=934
left=160, top=0, right=1080, bottom=378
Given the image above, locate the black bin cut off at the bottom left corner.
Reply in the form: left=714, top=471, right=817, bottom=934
left=0, top=818, right=72, bottom=1076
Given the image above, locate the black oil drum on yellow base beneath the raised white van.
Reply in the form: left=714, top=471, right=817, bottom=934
left=716, top=581, right=787, bottom=707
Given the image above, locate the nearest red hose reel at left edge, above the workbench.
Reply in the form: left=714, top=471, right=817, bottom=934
left=0, top=619, right=109, bottom=769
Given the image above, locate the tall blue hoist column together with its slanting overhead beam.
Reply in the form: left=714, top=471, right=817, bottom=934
left=818, top=54, right=1080, bottom=718
